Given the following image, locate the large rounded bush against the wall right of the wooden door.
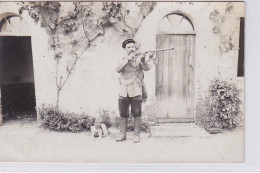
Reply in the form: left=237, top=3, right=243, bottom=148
left=196, top=78, right=241, bottom=130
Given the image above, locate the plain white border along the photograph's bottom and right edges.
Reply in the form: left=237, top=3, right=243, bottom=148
left=0, top=0, right=260, bottom=172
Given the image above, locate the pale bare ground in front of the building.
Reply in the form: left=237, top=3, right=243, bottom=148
left=0, top=120, right=244, bottom=163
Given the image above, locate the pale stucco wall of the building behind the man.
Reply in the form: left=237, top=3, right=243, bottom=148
left=0, top=2, right=244, bottom=117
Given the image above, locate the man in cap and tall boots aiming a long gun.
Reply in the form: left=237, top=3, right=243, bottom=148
left=116, top=39, right=153, bottom=143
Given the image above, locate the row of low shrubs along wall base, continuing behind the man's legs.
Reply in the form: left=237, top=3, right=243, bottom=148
left=39, top=106, right=155, bottom=133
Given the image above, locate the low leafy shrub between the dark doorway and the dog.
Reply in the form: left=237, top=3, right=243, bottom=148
left=39, top=106, right=94, bottom=133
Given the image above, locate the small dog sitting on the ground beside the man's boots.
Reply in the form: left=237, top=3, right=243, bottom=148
left=90, top=118, right=108, bottom=140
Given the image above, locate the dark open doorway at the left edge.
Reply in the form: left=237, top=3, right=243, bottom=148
left=0, top=36, right=36, bottom=119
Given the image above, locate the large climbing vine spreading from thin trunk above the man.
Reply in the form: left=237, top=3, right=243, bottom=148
left=19, top=1, right=156, bottom=107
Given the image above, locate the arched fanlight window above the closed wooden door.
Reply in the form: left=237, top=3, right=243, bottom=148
left=157, top=13, right=195, bottom=34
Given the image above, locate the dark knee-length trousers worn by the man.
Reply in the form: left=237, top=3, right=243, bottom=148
left=118, top=96, right=142, bottom=118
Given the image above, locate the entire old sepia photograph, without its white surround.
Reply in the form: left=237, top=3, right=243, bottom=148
left=0, top=1, right=245, bottom=163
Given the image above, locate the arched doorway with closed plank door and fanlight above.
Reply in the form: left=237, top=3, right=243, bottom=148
left=155, top=13, right=196, bottom=122
